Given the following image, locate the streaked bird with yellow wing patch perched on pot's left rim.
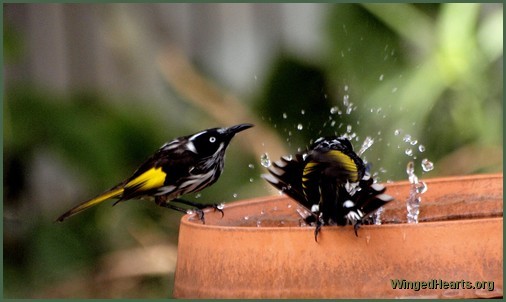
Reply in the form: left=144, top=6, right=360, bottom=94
left=56, top=123, right=254, bottom=223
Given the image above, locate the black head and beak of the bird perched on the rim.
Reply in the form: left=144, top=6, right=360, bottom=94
left=187, top=124, right=253, bottom=157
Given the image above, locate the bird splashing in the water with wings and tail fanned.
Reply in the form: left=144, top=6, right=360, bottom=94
left=262, top=135, right=393, bottom=241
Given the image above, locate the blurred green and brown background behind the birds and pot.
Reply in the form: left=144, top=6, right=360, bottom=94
left=3, top=4, right=503, bottom=298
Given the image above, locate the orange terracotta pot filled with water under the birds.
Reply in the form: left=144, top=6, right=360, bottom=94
left=174, top=174, right=503, bottom=298
